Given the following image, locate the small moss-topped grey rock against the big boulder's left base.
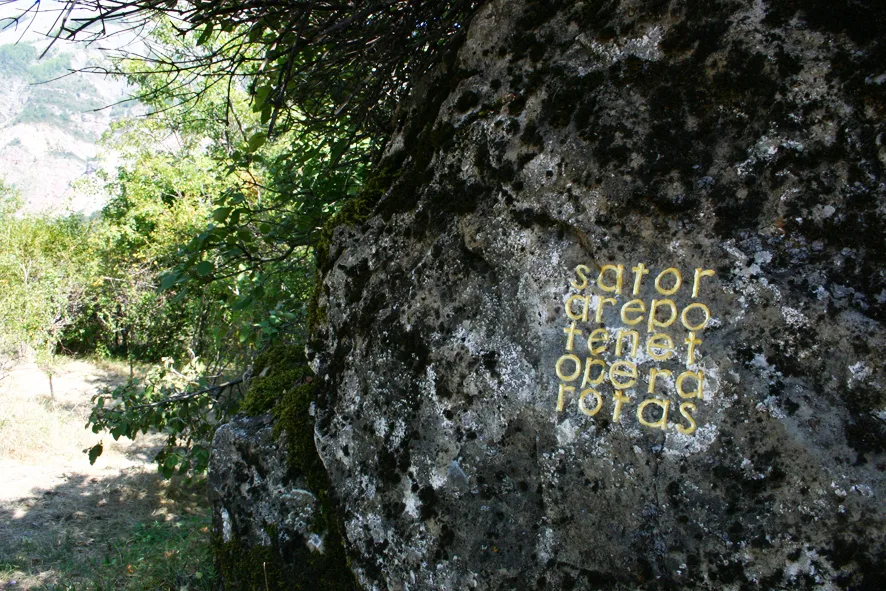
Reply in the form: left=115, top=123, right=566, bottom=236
left=208, top=345, right=356, bottom=591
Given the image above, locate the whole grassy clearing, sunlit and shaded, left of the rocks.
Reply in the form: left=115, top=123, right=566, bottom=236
left=0, top=361, right=216, bottom=591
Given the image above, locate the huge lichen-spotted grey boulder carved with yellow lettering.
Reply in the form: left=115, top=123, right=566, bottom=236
left=309, top=0, right=886, bottom=590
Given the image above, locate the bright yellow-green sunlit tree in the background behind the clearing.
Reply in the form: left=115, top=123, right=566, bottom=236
left=65, top=110, right=229, bottom=362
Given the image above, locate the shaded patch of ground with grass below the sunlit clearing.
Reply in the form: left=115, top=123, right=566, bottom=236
left=0, top=468, right=209, bottom=591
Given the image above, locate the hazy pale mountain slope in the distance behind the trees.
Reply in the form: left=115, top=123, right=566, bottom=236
left=0, top=27, right=133, bottom=212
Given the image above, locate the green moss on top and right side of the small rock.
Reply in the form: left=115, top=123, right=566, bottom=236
left=236, top=345, right=358, bottom=591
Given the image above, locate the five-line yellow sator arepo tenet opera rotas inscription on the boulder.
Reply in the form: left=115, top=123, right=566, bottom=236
left=554, top=263, right=715, bottom=434
